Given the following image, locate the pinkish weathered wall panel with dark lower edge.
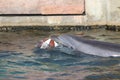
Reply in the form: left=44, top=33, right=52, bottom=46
left=0, top=0, right=84, bottom=14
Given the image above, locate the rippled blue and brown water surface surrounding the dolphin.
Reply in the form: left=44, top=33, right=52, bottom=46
left=0, top=30, right=120, bottom=80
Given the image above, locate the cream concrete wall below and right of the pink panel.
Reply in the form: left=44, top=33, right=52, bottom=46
left=0, top=0, right=120, bottom=26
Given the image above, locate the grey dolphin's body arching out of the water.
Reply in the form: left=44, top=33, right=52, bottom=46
left=52, top=34, right=120, bottom=57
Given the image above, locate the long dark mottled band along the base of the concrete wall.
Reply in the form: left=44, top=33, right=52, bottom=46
left=0, top=25, right=108, bottom=32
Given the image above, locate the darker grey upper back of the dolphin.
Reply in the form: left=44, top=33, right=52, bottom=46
left=69, top=35, right=120, bottom=52
